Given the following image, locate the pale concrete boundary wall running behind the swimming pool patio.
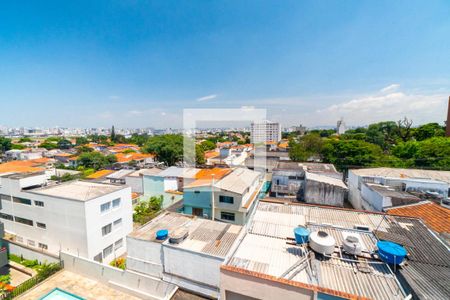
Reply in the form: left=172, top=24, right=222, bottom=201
left=61, top=252, right=178, bottom=299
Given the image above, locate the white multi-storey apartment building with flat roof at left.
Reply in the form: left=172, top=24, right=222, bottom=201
left=0, top=173, right=133, bottom=263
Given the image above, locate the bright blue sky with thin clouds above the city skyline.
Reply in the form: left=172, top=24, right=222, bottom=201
left=0, top=0, right=450, bottom=128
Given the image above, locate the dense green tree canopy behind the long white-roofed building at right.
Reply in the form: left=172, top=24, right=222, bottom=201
left=289, top=118, right=450, bottom=170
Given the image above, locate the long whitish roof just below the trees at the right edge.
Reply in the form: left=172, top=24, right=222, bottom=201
left=350, top=168, right=450, bottom=183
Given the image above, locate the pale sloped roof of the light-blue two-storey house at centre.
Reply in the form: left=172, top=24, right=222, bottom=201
left=214, top=168, right=261, bottom=194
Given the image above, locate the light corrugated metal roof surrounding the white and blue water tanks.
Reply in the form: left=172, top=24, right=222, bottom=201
left=227, top=201, right=405, bottom=299
